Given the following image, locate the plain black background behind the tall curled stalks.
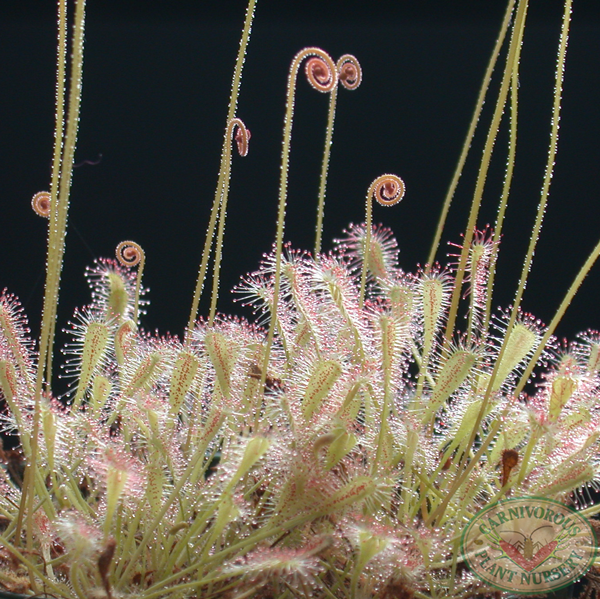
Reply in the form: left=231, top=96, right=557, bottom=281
left=0, top=0, right=600, bottom=386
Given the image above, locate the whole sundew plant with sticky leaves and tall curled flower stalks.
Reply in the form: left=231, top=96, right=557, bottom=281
left=0, top=0, right=600, bottom=599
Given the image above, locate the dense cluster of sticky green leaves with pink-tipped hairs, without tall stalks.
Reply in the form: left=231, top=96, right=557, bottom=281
left=0, top=226, right=600, bottom=599
